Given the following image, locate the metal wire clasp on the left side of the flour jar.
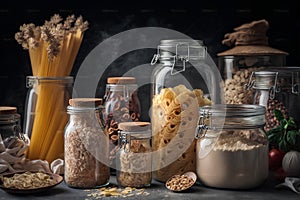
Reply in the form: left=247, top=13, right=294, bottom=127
left=195, top=111, right=212, bottom=139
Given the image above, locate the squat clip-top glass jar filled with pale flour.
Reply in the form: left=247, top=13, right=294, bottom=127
left=196, top=104, right=268, bottom=189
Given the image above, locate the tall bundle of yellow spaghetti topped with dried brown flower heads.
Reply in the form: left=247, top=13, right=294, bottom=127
left=15, top=14, right=88, bottom=162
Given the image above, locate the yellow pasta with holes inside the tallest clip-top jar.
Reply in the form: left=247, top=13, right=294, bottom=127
left=151, top=85, right=211, bottom=182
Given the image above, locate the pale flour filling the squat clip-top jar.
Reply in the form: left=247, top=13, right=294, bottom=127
left=196, top=131, right=268, bottom=189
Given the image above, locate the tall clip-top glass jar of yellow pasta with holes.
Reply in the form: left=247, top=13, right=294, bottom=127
left=151, top=39, right=221, bottom=182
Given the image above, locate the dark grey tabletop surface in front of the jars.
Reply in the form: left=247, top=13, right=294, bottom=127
left=0, top=176, right=300, bottom=200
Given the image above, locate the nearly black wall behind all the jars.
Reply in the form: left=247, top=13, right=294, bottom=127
left=0, top=0, right=300, bottom=123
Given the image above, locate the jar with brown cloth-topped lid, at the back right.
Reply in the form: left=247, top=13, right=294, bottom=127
left=218, top=20, right=288, bottom=104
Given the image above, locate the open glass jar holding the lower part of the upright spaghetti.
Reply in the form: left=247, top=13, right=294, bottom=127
left=24, top=76, right=73, bottom=163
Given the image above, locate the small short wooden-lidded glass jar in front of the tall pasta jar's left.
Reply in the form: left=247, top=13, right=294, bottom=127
left=116, top=122, right=152, bottom=188
